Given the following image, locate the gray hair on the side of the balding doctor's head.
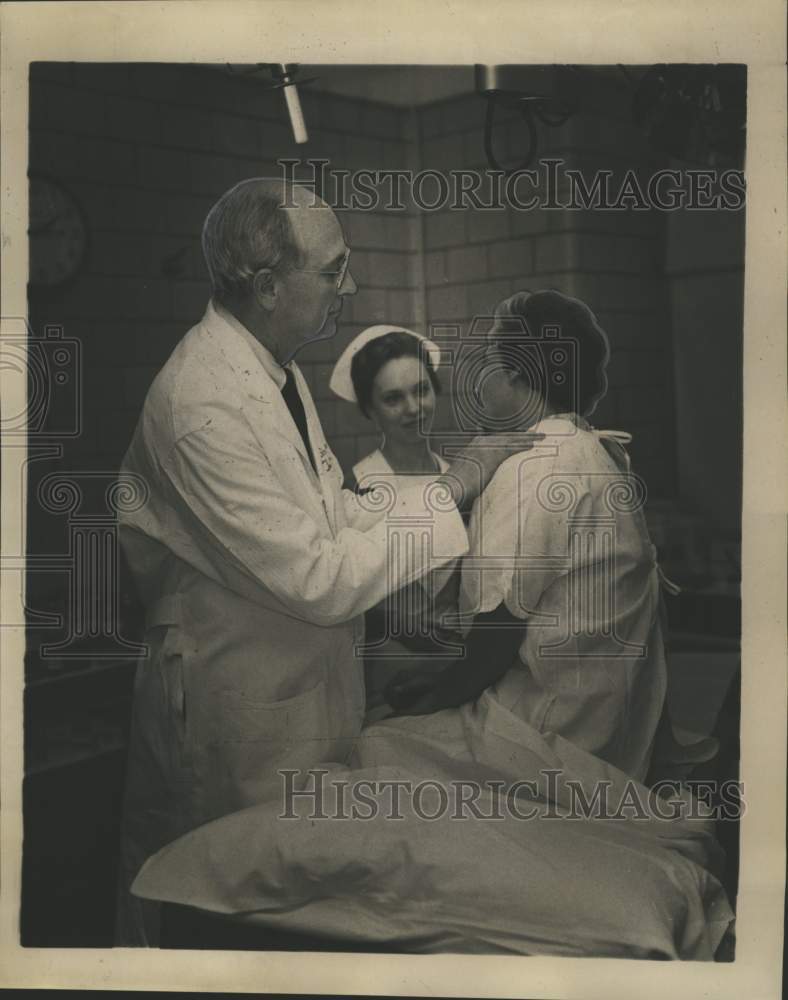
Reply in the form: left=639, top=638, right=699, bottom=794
left=202, top=177, right=299, bottom=305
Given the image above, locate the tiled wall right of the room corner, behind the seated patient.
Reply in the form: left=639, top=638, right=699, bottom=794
left=419, top=84, right=675, bottom=495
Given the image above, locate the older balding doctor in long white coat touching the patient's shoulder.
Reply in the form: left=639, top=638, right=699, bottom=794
left=116, top=179, right=536, bottom=945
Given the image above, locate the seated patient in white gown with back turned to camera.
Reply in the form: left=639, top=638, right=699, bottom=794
left=387, top=290, right=688, bottom=781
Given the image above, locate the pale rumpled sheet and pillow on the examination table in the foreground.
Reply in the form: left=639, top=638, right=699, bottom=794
left=133, top=693, right=732, bottom=960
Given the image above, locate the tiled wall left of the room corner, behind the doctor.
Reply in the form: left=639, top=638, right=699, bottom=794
left=30, top=64, right=424, bottom=484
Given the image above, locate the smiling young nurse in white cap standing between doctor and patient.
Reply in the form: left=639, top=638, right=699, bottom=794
left=329, top=324, right=458, bottom=722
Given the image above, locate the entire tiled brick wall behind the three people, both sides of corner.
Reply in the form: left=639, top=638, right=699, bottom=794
left=30, top=64, right=738, bottom=540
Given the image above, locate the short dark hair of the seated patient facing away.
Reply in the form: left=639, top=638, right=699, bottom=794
left=495, top=288, right=610, bottom=416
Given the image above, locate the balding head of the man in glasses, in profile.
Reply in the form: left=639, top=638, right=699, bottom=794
left=202, top=178, right=356, bottom=364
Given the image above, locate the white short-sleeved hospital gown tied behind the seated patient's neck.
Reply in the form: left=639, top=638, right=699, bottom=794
left=460, top=416, right=667, bottom=781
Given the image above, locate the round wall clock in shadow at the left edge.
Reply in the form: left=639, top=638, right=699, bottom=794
left=28, top=175, right=88, bottom=288
